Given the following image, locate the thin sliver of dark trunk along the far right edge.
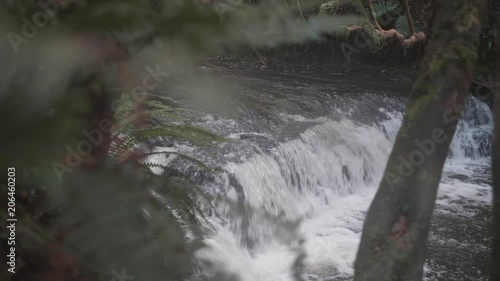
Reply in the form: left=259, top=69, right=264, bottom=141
left=490, top=15, right=500, bottom=281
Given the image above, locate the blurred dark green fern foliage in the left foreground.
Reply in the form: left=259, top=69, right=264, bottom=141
left=0, top=0, right=357, bottom=281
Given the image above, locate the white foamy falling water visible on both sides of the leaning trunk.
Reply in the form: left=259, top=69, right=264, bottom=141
left=188, top=95, right=492, bottom=281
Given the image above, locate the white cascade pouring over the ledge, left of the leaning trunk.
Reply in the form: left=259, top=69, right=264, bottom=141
left=193, top=120, right=391, bottom=280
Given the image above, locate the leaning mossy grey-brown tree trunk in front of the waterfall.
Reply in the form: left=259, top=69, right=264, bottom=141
left=354, top=0, right=486, bottom=281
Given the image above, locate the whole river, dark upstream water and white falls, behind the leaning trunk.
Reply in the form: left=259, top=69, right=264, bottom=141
left=146, top=63, right=492, bottom=281
